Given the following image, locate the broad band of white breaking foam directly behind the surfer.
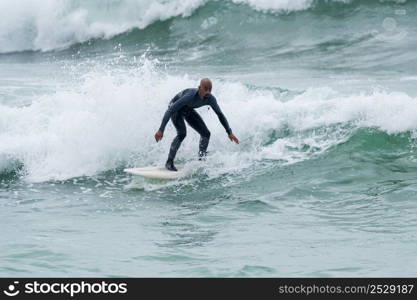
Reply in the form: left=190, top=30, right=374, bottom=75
left=0, top=60, right=417, bottom=181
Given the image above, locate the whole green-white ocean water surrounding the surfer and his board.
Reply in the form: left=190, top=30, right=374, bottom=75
left=0, top=0, right=417, bottom=277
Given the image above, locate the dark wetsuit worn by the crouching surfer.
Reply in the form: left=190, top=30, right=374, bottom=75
left=159, top=88, right=232, bottom=161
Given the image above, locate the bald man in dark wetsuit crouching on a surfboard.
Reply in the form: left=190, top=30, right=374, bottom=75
left=155, top=78, right=239, bottom=171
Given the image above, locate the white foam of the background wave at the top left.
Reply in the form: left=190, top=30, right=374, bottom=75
left=0, top=0, right=205, bottom=53
